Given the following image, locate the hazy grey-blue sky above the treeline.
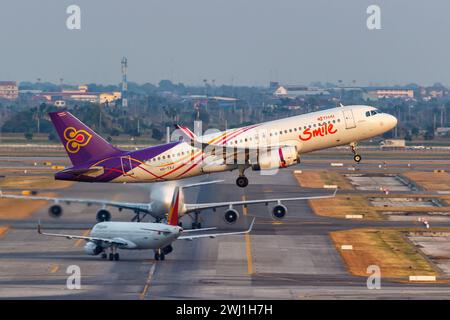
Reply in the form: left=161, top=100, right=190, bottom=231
left=0, top=0, right=450, bottom=86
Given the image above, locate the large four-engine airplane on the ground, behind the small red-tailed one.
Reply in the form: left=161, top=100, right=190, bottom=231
left=0, top=180, right=337, bottom=229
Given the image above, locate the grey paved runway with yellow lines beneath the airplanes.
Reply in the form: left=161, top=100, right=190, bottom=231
left=0, top=164, right=450, bottom=300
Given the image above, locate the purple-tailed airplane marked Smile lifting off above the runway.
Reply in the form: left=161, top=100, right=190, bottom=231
left=49, top=105, right=397, bottom=187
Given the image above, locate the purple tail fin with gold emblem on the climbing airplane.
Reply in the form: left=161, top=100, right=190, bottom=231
left=49, top=111, right=122, bottom=166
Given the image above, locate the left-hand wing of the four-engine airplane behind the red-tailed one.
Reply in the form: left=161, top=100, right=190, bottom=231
left=0, top=191, right=152, bottom=212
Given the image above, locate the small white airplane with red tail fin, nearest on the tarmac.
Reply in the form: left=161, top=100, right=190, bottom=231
left=38, top=186, right=255, bottom=261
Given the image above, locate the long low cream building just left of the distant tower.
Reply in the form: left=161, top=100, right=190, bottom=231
left=37, top=85, right=122, bottom=105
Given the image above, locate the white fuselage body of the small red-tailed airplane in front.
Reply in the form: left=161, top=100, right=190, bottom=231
left=90, top=222, right=183, bottom=249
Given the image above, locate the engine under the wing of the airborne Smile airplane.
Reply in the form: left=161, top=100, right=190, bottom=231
left=252, top=146, right=300, bottom=171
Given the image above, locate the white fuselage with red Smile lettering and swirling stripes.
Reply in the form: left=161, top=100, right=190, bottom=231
left=114, top=105, right=397, bottom=182
